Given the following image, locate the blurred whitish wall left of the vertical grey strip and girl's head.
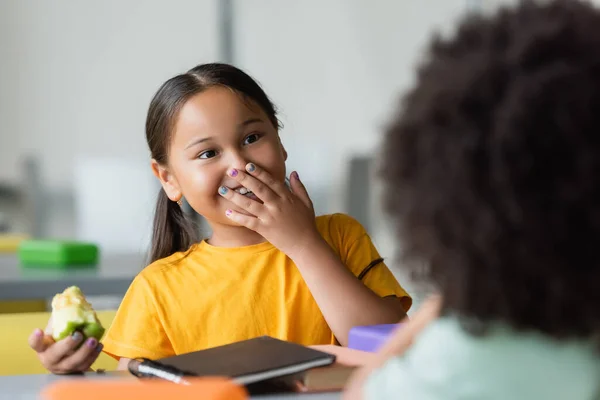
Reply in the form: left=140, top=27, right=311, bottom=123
left=0, top=0, right=217, bottom=188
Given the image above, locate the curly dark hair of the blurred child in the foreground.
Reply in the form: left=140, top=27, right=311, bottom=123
left=381, top=0, right=600, bottom=339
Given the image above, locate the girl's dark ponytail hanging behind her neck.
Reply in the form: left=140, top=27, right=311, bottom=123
left=150, top=189, right=197, bottom=263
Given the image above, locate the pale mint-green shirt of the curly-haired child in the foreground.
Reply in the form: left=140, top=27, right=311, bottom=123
left=364, top=318, right=600, bottom=400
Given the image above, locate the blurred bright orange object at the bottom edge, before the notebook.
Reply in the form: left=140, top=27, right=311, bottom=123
left=41, top=378, right=249, bottom=400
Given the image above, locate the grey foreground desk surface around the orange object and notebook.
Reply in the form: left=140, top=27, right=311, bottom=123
left=0, top=374, right=340, bottom=400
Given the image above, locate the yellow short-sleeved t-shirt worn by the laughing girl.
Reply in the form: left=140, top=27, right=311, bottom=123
left=103, top=214, right=412, bottom=359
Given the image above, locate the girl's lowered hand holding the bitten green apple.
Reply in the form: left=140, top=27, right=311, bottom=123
left=29, top=318, right=102, bottom=374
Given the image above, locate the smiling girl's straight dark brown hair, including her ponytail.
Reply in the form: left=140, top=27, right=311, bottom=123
left=146, top=63, right=279, bottom=262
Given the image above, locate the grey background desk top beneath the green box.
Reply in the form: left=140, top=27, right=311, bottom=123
left=0, top=254, right=145, bottom=301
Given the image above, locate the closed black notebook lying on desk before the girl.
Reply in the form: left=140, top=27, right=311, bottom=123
left=148, top=336, right=336, bottom=385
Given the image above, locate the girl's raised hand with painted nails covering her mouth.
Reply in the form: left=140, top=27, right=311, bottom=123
left=219, top=163, right=322, bottom=258
